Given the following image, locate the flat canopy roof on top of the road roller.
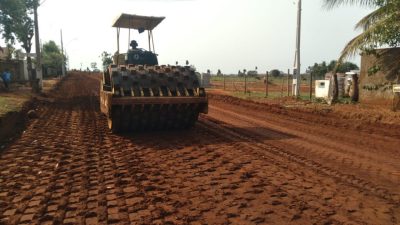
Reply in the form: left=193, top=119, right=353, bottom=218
left=113, top=13, right=165, bottom=31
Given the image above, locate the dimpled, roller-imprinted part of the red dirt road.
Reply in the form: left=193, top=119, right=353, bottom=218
left=0, top=74, right=400, bottom=224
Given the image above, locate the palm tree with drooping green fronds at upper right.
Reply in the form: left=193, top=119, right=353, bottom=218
left=324, top=0, right=400, bottom=101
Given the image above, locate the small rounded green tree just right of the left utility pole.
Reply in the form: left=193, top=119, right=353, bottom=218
left=42, top=41, right=66, bottom=70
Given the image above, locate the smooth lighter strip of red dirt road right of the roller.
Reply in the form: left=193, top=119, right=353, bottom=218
left=210, top=96, right=400, bottom=191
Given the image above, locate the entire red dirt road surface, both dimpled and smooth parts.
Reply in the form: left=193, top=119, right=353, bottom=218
left=0, top=74, right=400, bottom=224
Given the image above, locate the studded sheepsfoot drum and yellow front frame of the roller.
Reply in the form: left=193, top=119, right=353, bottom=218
left=100, top=65, right=208, bottom=132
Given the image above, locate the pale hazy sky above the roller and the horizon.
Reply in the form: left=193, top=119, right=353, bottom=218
left=1, top=0, right=371, bottom=74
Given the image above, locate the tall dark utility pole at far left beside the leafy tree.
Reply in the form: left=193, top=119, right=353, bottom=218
left=32, top=0, right=42, bottom=92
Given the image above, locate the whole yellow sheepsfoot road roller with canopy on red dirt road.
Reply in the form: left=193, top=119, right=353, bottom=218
left=100, top=14, right=208, bottom=133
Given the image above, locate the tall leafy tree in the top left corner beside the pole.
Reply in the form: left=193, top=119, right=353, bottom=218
left=0, top=0, right=39, bottom=81
